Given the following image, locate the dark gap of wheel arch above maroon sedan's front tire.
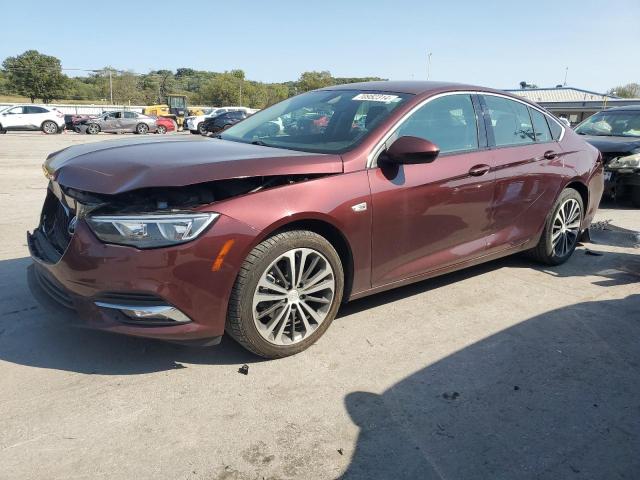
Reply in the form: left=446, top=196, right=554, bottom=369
left=251, top=216, right=354, bottom=302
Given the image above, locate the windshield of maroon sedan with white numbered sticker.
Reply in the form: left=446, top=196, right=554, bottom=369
left=219, top=90, right=412, bottom=153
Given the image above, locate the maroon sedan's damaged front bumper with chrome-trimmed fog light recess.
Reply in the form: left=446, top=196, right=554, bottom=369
left=27, top=216, right=255, bottom=345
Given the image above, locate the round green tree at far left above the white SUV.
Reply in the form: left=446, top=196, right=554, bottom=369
left=2, top=50, right=67, bottom=103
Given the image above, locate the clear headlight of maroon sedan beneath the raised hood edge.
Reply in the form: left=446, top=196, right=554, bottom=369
left=87, top=213, right=220, bottom=248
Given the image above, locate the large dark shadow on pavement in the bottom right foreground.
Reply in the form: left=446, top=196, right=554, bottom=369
left=340, top=294, right=640, bottom=480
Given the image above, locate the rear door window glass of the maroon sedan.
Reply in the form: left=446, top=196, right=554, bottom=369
left=483, top=95, right=535, bottom=147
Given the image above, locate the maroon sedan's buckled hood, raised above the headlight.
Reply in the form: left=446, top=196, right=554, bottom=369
left=44, top=136, right=343, bottom=194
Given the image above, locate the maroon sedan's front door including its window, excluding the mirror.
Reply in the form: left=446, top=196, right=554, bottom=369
left=369, top=94, right=494, bottom=287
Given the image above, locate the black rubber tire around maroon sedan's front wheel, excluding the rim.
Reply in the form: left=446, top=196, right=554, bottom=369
left=225, top=230, right=344, bottom=358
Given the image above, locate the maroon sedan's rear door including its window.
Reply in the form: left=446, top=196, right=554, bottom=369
left=480, top=94, right=563, bottom=252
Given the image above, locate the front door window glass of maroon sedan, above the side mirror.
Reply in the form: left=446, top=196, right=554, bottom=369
left=396, top=95, right=478, bottom=153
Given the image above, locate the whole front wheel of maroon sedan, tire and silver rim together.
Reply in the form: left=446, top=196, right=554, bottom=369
left=226, top=230, right=344, bottom=358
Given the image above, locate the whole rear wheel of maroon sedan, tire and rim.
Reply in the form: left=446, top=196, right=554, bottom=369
left=531, top=188, right=584, bottom=265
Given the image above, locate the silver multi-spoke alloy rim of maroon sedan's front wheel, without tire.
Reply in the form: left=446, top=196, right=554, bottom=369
left=253, top=248, right=336, bottom=345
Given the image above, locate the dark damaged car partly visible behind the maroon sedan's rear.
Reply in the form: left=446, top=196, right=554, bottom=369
left=576, top=106, right=640, bottom=208
